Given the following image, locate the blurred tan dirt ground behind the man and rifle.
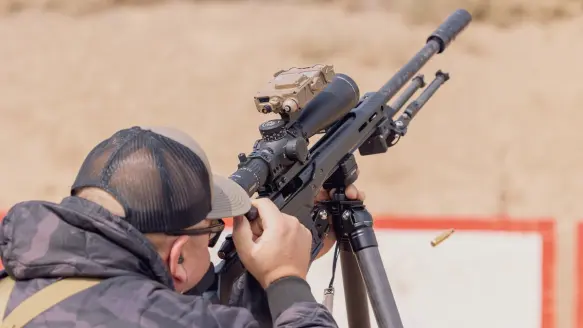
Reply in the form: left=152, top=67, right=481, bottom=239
left=0, top=0, right=583, bottom=328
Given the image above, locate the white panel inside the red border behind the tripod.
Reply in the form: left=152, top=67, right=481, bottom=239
left=214, top=230, right=542, bottom=328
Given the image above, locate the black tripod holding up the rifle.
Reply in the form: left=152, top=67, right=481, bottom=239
left=314, top=155, right=403, bottom=328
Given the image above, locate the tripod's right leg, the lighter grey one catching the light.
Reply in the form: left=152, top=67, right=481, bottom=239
left=352, top=227, right=403, bottom=328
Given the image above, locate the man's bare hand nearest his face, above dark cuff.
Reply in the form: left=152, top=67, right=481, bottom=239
left=233, top=198, right=312, bottom=288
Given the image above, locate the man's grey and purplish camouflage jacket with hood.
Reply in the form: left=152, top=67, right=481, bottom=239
left=0, top=197, right=337, bottom=328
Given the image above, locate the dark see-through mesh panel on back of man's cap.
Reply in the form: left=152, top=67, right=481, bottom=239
left=72, top=127, right=211, bottom=233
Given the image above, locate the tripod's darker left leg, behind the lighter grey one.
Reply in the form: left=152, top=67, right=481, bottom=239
left=340, top=248, right=370, bottom=328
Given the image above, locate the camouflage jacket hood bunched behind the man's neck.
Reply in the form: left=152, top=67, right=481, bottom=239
left=0, top=196, right=174, bottom=289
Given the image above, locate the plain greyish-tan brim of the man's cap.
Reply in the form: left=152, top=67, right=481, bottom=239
left=207, top=174, right=251, bottom=219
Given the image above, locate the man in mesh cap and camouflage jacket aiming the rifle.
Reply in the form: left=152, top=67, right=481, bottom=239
left=0, top=127, right=363, bottom=328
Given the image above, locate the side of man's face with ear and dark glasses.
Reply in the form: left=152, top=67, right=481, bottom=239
left=176, top=220, right=224, bottom=291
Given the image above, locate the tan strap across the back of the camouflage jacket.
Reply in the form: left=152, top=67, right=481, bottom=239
left=0, top=276, right=101, bottom=328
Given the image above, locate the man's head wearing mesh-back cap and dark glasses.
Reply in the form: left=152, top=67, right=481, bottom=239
left=71, top=127, right=251, bottom=291
